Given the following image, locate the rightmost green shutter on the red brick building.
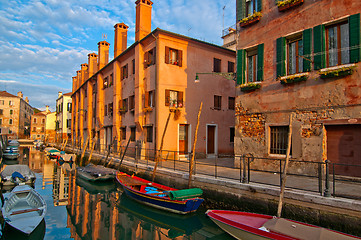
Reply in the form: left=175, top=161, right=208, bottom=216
left=348, top=13, right=361, bottom=63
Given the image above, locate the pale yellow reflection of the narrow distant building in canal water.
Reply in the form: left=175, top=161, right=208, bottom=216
left=53, top=164, right=70, bottom=206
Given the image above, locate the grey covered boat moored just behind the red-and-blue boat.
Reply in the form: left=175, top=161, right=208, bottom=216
left=76, top=163, right=116, bottom=181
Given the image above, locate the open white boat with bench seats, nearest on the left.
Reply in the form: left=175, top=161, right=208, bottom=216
left=2, top=185, right=46, bottom=235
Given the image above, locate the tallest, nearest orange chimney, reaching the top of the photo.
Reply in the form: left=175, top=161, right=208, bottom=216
left=135, top=0, right=153, bottom=41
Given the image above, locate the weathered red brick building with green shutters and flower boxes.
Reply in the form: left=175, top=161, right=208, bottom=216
left=235, top=0, right=361, bottom=176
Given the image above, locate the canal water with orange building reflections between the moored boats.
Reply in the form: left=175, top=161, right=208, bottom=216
left=2, top=146, right=232, bottom=240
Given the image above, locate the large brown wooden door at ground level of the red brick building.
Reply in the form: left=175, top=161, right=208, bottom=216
left=326, top=124, right=361, bottom=177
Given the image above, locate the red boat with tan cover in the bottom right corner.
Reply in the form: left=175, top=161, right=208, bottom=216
left=206, top=210, right=361, bottom=240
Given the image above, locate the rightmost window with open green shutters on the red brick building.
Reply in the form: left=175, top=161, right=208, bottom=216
left=313, top=13, right=361, bottom=70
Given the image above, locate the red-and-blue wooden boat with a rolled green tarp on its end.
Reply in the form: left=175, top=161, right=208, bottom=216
left=117, top=172, right=204, bottom=214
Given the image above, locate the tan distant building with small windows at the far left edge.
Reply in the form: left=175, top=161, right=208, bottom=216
left=0, top=91, right=34, bottom=138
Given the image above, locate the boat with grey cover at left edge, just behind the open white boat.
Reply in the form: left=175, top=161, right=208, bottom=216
left=0, top=165, right=36, bottom=187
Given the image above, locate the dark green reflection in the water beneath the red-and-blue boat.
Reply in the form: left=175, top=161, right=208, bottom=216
left=118, top=194, right=203, bottom=239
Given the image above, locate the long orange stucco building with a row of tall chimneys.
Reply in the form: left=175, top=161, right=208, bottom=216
left=72, top=1, right=235, bottom=158
